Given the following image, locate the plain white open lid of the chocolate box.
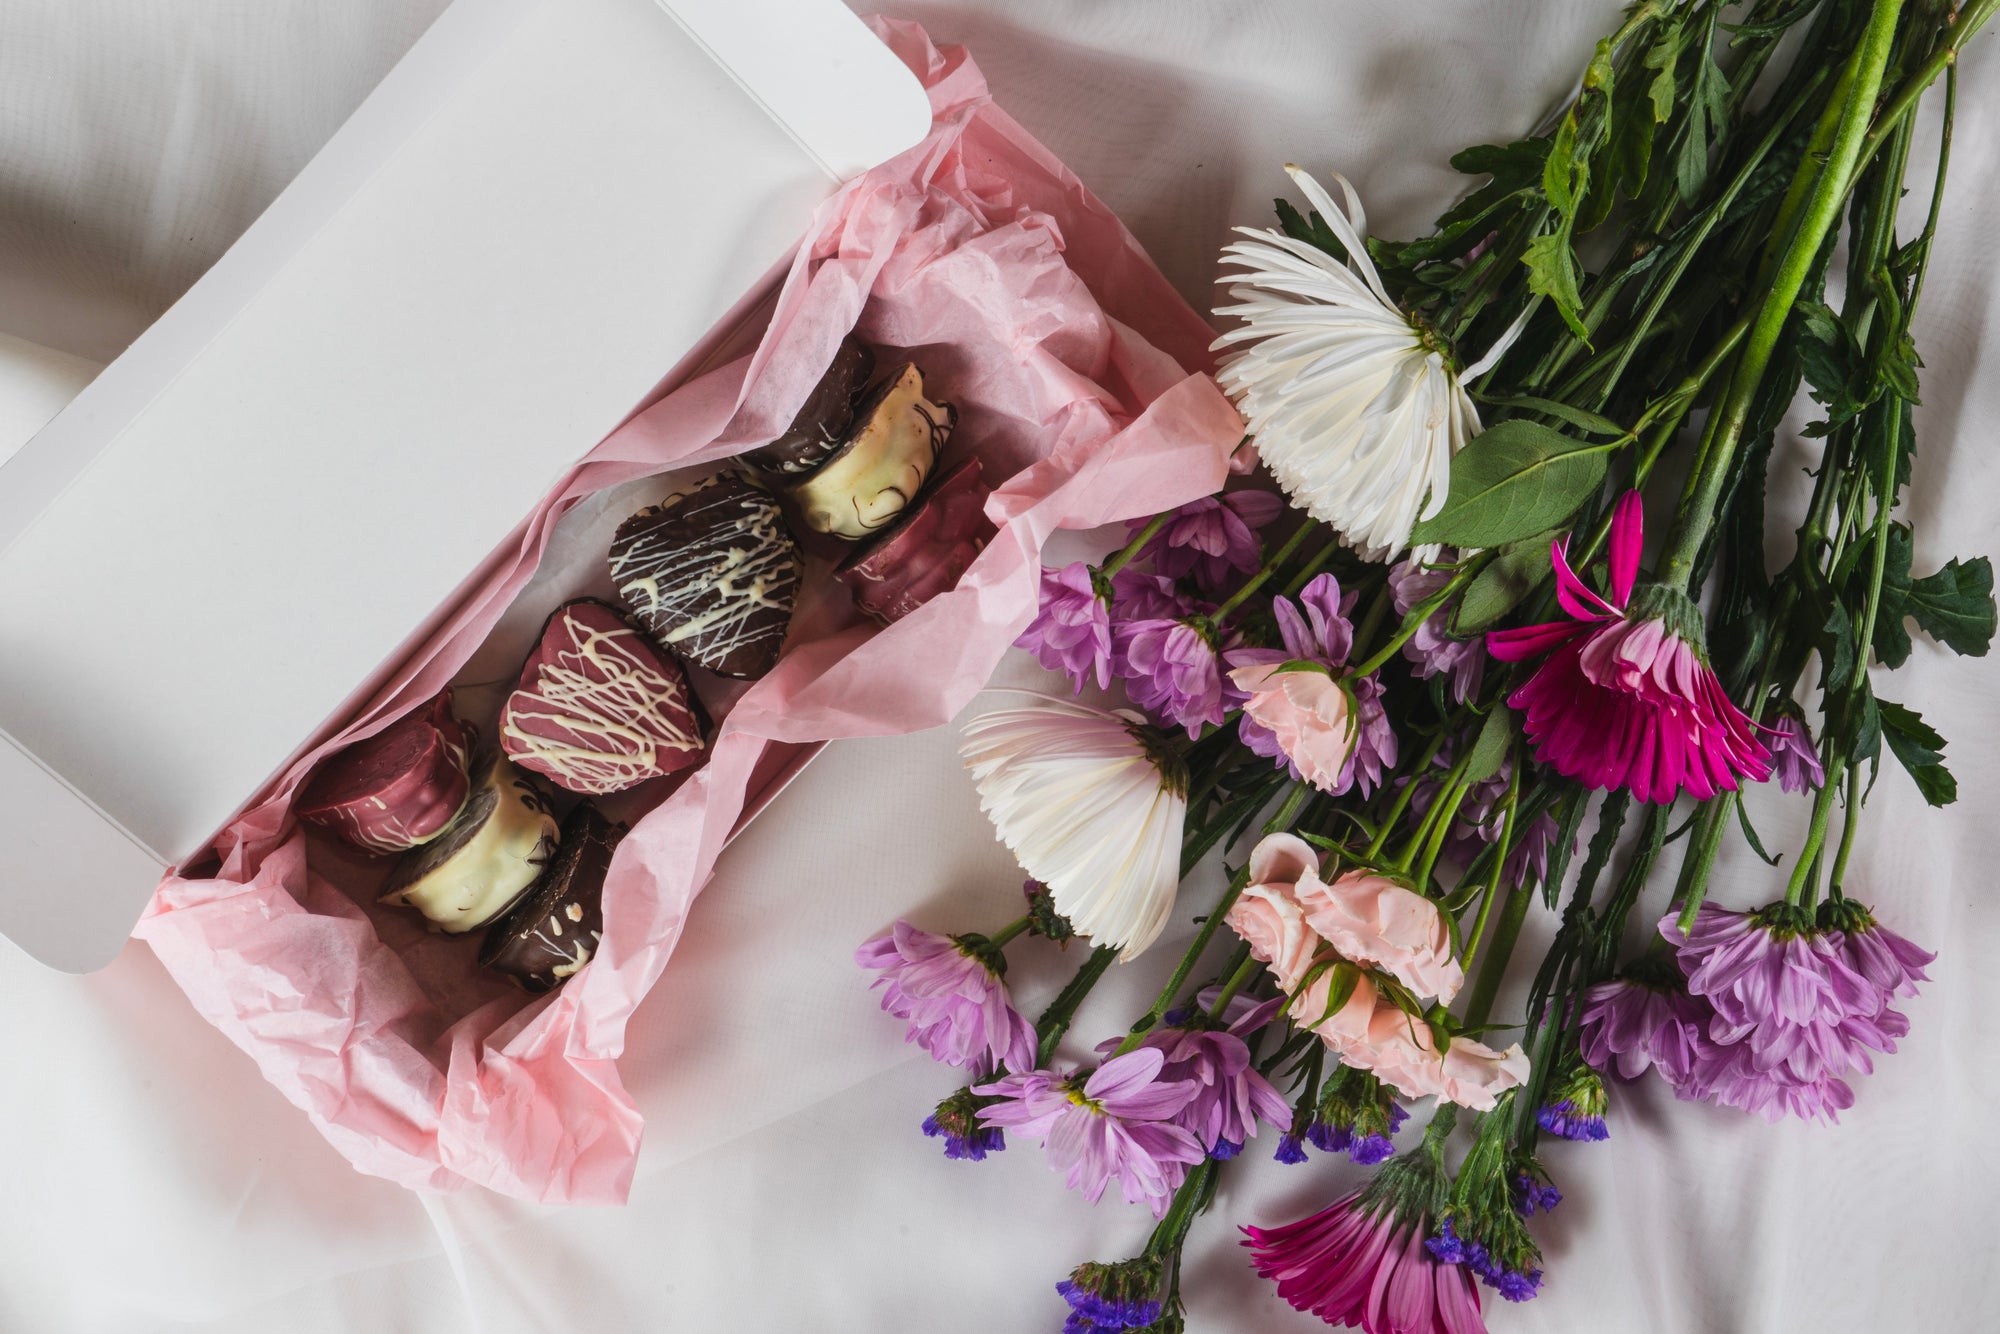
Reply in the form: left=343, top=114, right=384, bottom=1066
left=0, top=0, right=930, bottom=972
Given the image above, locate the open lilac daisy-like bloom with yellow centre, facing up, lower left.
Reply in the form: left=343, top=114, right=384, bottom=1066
left=972, top=1046, right=1208, bottom=1218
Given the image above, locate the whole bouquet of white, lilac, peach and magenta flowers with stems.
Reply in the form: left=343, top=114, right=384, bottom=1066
left=858, top=0, right=2000, bottom=1334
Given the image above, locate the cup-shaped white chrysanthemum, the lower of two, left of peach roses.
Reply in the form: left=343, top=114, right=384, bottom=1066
left=960, top=696, right=1188, bottom=960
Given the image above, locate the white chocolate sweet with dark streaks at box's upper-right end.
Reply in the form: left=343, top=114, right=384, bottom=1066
left=788, top=362, right=958, bottom=540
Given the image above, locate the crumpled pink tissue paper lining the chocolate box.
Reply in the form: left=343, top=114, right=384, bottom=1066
left=134, top=20, right=1242, bottom=1204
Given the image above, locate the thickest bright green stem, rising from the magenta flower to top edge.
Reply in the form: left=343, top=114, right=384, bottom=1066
left=1660, top=0, right=1902, bottom=588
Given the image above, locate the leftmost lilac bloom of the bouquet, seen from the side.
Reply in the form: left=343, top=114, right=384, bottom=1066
left=854, top=922, right=1034, bottom=1074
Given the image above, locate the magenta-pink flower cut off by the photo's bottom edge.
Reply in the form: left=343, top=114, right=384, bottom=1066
left=1244, top=1154, right=1486, bottom=1334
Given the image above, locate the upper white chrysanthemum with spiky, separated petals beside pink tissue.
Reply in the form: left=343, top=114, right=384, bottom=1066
left=1214, top=166, right=1520, bottom=556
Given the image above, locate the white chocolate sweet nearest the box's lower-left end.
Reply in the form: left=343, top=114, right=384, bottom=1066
left=382, top=750, right=558, bottom=934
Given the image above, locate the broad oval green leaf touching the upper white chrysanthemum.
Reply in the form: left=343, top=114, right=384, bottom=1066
left=1410, top=420, right=1606, bottom=548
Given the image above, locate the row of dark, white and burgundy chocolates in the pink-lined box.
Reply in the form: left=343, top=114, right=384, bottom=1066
left=296, top=338, right=992, bottom=992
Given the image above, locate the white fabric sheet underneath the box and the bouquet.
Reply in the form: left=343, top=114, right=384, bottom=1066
left=0, top=0, right=2000, bottom=1334
